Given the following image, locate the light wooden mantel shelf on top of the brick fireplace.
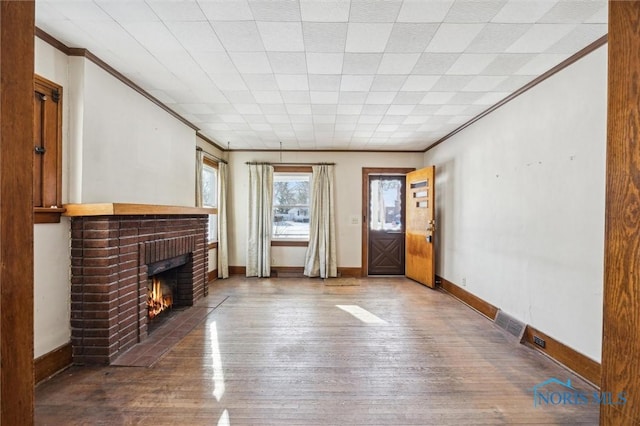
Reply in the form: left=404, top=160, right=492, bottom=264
left=64, top=203, right=218, bottom=217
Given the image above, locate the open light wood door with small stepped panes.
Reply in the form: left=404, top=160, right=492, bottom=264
left=405, top=166, right=436, bottom=288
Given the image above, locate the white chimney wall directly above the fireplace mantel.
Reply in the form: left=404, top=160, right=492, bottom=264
left=71, top=59, right=196, bottom=206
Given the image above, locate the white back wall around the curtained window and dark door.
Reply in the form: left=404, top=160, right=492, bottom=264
left=228, top=151, right=423, bottom=268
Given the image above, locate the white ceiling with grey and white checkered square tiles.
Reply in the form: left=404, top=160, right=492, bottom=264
left=36, top=0, right=607, bottom=150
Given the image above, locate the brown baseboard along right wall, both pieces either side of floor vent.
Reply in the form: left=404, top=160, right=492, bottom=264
left=436, top=276, right=602, bottom=387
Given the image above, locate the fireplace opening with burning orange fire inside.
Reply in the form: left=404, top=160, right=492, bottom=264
left=147, top=254, right=189, bottom=333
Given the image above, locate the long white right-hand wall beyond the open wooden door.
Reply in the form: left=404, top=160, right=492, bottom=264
left=424, top=46, right=607, bottom=361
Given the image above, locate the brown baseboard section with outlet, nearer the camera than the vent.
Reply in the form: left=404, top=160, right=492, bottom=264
left=522, top=325, right=602, bottom=387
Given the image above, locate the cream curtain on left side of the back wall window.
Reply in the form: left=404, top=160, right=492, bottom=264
left=246, top=164, right=273, bottom=277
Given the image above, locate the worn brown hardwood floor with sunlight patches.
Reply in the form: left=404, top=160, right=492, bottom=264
left=36, top=277, right=599, bottom=426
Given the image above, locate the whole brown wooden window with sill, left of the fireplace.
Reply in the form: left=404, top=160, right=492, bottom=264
left=33, top=75, right=64, bottom=223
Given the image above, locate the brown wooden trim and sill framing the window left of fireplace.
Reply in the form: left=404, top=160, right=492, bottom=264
left=33, top=74, right=66, bottom=224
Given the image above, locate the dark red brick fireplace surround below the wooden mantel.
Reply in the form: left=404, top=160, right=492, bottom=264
left=70, top=205, right=208, bottom=365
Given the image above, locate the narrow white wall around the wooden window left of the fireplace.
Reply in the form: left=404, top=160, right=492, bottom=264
left=33, top=38, right=71, bottom=357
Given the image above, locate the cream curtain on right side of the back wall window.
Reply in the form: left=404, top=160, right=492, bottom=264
left=304, top=165, right=338, bottom=278
